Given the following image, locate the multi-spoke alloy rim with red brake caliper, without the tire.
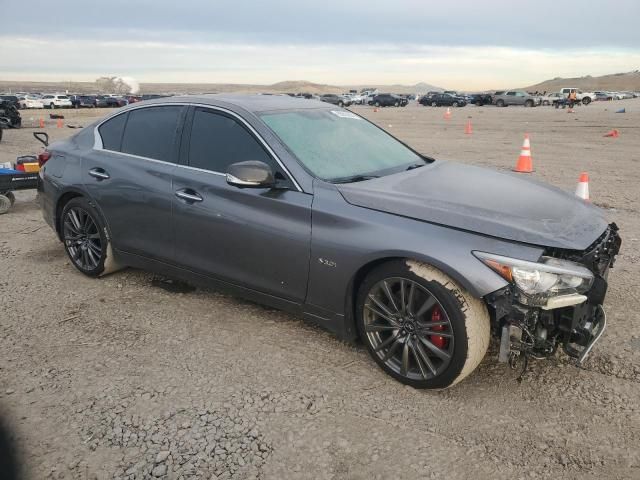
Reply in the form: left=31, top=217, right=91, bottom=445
left=363, top=277, right=455, bottom=381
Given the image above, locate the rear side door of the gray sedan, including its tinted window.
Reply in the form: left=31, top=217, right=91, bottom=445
left=82, top=105, right=187, bottom=261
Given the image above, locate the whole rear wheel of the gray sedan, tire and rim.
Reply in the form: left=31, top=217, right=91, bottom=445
left=60, top=197, right=110, bottom=277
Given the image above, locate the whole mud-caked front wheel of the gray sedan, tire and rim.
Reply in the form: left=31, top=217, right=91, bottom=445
left=356, top=260, right=490, bottom=389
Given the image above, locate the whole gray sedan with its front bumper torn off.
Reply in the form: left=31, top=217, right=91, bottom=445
left=39, top=95, right=620, bottom=388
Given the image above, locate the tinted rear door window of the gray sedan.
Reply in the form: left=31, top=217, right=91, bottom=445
left=121, top=105, right=183, bottom=163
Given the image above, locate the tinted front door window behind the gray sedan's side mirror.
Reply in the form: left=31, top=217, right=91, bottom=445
left=189, top=109, right=277, bottom=173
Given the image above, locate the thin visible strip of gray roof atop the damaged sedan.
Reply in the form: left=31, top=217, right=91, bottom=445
left=135, top=93, right=336, bottom=113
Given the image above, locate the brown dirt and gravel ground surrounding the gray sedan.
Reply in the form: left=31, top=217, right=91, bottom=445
left=0, top=99, right=640, bottom=480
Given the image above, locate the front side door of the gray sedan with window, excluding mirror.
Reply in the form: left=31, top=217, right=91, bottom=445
left=173, top=107, right=312, bottom=303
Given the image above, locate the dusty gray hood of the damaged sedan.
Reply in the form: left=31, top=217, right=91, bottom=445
left=337, top=160, right=607, bottom=250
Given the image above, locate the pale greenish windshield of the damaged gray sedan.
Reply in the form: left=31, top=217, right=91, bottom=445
left=261, top=109, right=425, bottom=182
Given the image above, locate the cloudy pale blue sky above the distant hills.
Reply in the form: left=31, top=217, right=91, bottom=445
left=0, top=0, right=640, bottom=90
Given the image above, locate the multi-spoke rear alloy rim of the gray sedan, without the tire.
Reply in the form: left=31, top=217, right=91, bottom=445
left=63, top=207, right=102, bottom=270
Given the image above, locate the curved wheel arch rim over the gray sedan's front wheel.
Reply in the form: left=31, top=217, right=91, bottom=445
left=344, top=252, right=482, bottom=337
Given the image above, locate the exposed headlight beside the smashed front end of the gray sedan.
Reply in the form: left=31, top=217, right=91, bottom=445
left=473, top=252, right=593, bottom=306
